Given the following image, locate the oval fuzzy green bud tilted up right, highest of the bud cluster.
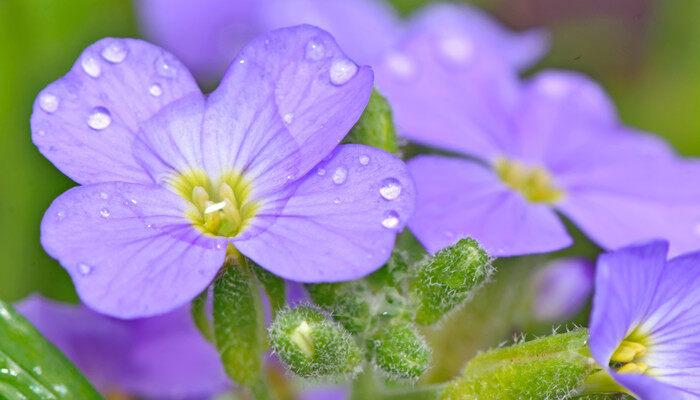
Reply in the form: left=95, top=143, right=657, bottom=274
left=411, top=238, right=493, bottom=325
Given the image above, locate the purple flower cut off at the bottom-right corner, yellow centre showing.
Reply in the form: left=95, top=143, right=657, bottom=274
left=590, top=241, right=700, bottom=400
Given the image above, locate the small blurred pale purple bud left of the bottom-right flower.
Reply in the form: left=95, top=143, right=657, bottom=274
left=532, top=258, right=594, bottom=322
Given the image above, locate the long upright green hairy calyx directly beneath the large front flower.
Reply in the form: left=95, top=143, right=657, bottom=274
left=214, top=263, right=265, bottom=388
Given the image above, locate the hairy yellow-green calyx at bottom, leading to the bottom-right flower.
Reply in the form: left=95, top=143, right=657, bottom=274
left=442, top=329, right=594, bottom=400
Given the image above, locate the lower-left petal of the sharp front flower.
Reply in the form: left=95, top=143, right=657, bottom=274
left=41, top=183, right=226, bottom=318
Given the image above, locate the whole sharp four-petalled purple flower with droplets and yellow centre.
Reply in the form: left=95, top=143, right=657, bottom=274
left=31, top=26, right=414, bottom=318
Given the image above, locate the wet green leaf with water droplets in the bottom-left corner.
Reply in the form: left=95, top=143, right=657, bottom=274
left=0, top=301, right=102, bottom=400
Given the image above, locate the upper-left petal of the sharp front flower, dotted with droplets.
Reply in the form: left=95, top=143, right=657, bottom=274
left=31, top=38, right=201, bottom=184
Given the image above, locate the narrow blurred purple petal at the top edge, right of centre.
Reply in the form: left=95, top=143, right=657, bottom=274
left=411, top=3, right=549, bottom=69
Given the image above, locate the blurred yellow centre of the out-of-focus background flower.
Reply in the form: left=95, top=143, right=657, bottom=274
left=493, top=158, right=564, bottom=204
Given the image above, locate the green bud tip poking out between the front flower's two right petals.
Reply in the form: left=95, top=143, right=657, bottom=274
left=345, top=89, right=399, bottom=153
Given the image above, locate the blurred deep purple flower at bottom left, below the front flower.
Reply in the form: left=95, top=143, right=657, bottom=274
left=17, top=296, right=229, bottom=399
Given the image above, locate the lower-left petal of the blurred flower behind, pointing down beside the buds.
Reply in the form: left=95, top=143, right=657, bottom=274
left=409, top=156, right=571, bottom=256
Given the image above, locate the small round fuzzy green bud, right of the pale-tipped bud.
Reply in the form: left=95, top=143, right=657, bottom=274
left=370, top=323, right=430, bottom=379
